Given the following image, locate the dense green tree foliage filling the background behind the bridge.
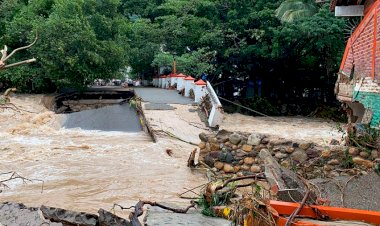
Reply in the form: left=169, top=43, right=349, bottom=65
left=0, top=0, right=345, bottom=114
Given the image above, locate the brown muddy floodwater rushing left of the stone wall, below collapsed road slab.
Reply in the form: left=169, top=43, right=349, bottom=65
left=0, top=95, right=206, bottom=215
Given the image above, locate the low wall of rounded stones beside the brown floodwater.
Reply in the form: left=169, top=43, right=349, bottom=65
left=199, top=130, right=380, bottom=179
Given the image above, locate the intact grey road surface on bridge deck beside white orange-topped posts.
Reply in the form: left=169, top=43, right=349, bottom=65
left=134, top=87, right=194, bottom=104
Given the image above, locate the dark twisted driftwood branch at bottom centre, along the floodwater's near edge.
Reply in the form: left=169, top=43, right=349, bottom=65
left=113, top=201, right=195, bottom=226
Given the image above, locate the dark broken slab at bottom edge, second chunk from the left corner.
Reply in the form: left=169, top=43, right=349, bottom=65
left=40, top=205, right=98, bottom=226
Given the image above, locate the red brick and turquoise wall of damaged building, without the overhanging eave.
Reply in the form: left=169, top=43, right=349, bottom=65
left=338, top=0, right=380, bottom=127
